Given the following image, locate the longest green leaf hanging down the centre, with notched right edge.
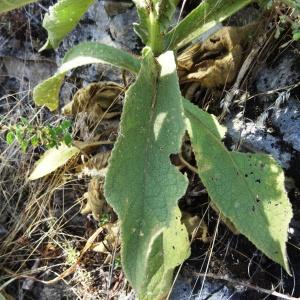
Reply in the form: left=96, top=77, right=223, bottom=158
left=104, top=48, right=188, bottom=299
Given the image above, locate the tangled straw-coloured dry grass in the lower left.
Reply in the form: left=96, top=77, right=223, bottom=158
left=0, top=92, right=126, bottom=299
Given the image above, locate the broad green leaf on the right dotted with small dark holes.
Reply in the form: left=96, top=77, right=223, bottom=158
left=184, top=100, right=292, bottom=272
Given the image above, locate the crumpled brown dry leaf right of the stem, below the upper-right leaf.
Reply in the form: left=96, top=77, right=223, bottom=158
left=178, top=24, right=257, bottom=96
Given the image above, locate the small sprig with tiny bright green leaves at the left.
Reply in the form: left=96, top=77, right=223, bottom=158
left=6, top=117, right=72, bottom=152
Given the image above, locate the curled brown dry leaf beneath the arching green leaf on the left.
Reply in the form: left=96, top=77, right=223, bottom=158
left=62, top=81, right=124, bottom=123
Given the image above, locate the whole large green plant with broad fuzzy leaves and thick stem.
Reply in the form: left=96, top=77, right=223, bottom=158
left=0, top=0, right=292, bottom=299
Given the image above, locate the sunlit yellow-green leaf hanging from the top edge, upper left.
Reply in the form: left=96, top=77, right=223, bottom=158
left=40, top=0, right=94, bottom=51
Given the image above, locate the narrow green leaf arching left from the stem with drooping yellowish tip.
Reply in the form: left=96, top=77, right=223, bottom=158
left=33, top=42, right=140, bottom=110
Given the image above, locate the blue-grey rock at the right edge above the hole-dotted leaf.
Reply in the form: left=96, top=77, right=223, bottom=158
left=226, top=52, right=300, bottom=169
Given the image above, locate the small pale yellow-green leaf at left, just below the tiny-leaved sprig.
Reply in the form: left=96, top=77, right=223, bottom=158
left=29, top=144, right=80, bottom=180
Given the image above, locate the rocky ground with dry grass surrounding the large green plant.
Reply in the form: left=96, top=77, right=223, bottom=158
left=0, top=0, right=300, bottom=300
